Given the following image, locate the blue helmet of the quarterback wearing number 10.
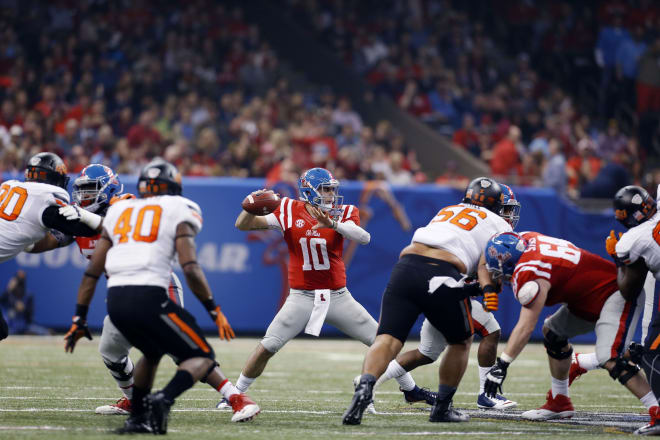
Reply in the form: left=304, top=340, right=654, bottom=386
left=298, top=168, right=344, bottom=217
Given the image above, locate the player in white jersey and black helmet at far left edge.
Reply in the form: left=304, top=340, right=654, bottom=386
left=0, top=153, right=100, bottom=340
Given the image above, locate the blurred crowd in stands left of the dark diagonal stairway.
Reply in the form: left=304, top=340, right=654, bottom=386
left=0, top=0, right=425, bottom=184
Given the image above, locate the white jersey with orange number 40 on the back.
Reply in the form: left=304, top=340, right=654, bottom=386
left=103, top=196, right=202, bottom=289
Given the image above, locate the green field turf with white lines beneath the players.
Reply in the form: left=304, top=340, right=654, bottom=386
left=0, top=336, right=645, bottom=440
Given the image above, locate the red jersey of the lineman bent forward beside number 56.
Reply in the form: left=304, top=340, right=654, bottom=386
left=511, top=232, right=619, bottom=322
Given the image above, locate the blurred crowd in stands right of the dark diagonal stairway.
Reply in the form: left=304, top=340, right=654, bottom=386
left=285, top=0, right=660, bottom=197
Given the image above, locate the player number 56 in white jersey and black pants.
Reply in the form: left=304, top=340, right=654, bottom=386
left=343, top=177, right=511, bottom=425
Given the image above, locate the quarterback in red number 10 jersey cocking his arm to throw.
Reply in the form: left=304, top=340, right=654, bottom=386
left=229, top=168, right=378, bottom=407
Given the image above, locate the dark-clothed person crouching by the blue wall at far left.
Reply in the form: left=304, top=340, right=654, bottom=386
left=0, top=270, right=51, bottom=335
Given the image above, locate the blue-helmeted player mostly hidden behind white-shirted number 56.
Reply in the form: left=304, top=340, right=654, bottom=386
left=376, top=183, right=520, bottom=410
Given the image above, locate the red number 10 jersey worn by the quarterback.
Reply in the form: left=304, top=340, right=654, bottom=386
left=271, top=197, right=360, bottom=290
